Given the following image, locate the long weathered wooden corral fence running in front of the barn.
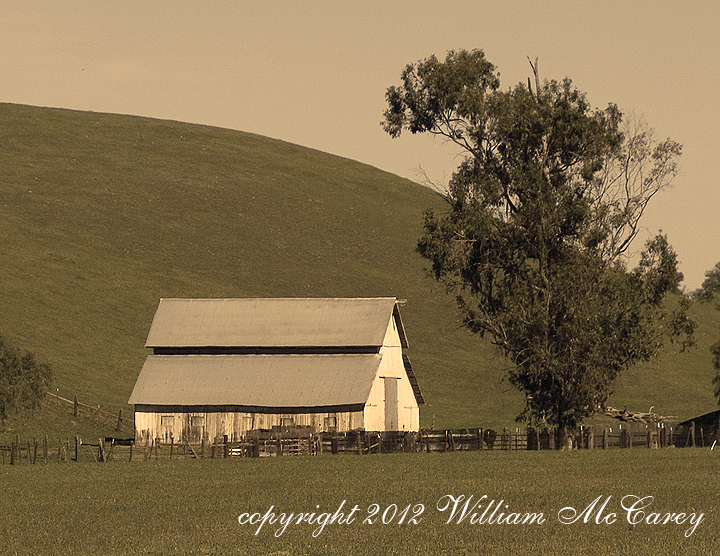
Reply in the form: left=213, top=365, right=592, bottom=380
left=0, top=423, right=719, bottom=464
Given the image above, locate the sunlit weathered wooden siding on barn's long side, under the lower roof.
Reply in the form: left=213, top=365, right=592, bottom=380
left=135, top=405, right=364, bottom=443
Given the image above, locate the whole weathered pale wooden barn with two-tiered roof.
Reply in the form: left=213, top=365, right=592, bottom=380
left=128, top=297, right=423, bottom=442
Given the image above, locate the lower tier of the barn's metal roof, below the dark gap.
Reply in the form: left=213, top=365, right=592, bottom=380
left=128, top=354, right=381, bottom=407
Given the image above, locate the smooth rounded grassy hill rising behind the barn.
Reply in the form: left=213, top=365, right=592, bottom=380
left=0, top=104, right=720, bottom=432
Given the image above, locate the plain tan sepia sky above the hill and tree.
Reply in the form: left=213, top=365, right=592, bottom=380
left=0, top=0, right=720, bottom=291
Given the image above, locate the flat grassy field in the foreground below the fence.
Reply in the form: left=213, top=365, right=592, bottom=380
left=0, top=449, right=720, bottom=555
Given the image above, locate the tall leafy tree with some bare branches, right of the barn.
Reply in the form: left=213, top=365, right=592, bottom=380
left=383, top=50, right=693, bottom=444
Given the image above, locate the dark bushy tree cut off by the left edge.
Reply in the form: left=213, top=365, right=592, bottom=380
left=0, top=334, right=52, bottom=421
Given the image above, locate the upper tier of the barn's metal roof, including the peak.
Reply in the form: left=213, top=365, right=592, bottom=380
left=146, top=297, right=407, bottom=348
